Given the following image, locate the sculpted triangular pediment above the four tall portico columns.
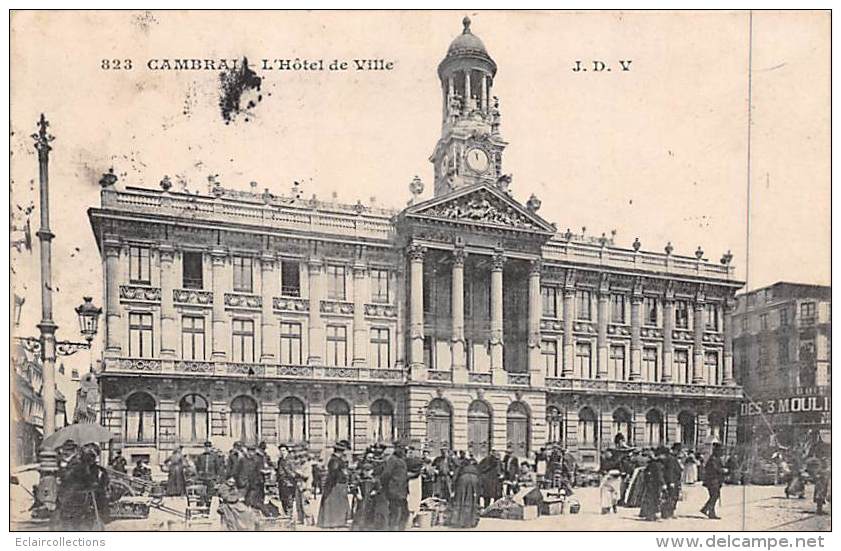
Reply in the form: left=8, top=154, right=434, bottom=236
left=403, top=183, right=555, bottom=234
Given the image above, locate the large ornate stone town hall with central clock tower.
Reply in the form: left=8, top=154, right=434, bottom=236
left=89, top=20, right=742, bottom=465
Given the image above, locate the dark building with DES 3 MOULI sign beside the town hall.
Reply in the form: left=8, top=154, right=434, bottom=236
left=733, top=282, right=832, bottom=448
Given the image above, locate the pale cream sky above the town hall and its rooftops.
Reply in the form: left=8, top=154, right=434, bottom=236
left=11, top=11, right=830, bottom=340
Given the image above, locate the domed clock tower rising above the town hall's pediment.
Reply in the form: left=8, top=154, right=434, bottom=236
left=429, top=17, right=508, bottom=197
